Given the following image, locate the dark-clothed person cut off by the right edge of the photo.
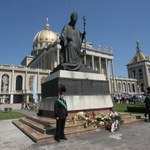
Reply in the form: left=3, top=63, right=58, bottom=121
left=144, top=87, right=150, bottom=122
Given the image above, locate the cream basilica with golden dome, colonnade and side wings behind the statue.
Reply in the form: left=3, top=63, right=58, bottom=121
left=0, top=20, right=150, bottom=104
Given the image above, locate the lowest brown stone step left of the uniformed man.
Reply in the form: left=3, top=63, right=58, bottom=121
left=13, top=120, right=54, bottom=143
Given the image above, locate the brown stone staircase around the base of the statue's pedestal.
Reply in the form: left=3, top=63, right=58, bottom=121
left=12, top=113, right=144, bottom=143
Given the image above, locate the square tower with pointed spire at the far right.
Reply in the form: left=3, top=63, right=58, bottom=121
left=127, top=41, right=150, bottom=93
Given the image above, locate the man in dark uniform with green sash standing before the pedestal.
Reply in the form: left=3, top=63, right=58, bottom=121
left=54, top=92, right=68, bottom=142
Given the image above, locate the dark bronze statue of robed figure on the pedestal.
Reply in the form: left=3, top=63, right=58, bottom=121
left=60, top=12, right=86, bottom=71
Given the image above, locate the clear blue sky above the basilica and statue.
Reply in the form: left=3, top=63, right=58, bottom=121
left=0, top=0, right=150, bottom=77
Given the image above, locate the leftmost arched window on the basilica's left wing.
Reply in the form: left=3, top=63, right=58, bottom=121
left=1, top=74, right=9, bottom=92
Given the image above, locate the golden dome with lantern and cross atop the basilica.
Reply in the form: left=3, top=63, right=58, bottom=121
left=31, top=19, right=58, bottom=55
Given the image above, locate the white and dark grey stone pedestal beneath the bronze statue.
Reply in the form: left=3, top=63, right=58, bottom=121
left=40, top=70, right=113, bottom=117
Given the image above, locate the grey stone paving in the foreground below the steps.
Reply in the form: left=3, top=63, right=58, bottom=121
left=0, top=117, right=150, bottom=150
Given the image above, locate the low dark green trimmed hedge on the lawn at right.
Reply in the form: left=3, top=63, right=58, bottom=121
left=127, top=105, right=145, bottom=113
